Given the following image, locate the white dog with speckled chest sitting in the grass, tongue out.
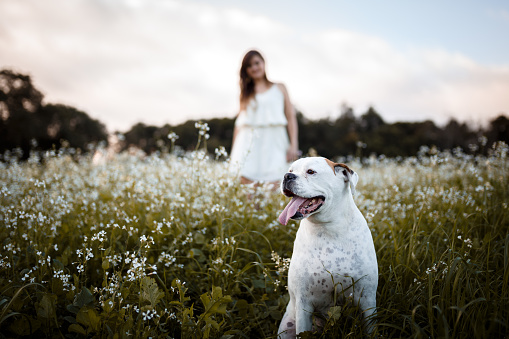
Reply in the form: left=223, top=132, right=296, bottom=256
left=278, top=157, right=378, bottom=338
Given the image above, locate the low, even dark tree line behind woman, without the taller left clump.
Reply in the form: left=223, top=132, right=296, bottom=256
left=123, top=106, right=509, bottom=158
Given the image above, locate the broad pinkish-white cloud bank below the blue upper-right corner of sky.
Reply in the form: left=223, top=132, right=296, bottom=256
left=0, top=0, right=509, bottom=129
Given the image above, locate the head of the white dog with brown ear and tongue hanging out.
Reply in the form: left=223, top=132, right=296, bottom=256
left=279, top=157, right=359, bottom=225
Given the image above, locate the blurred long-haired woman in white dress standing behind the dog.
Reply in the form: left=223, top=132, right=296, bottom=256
left=231, top=50, right=299, bottom=184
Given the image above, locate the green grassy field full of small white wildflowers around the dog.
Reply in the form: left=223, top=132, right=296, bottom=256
left=0, top=139, right=509, bottom=338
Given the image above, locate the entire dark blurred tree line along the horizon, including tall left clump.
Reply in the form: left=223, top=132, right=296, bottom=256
left=0, top=70, right=509, bottom=158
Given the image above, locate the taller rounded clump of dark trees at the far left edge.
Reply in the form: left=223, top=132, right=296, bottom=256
left=0, top=70, right=108, bottom=158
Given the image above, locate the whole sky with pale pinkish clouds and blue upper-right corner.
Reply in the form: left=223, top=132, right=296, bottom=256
left=0, top=0, right=509, bottom=131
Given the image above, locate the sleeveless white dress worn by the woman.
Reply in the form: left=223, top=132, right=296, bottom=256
left=230, top=84, right=290, bottom=181
